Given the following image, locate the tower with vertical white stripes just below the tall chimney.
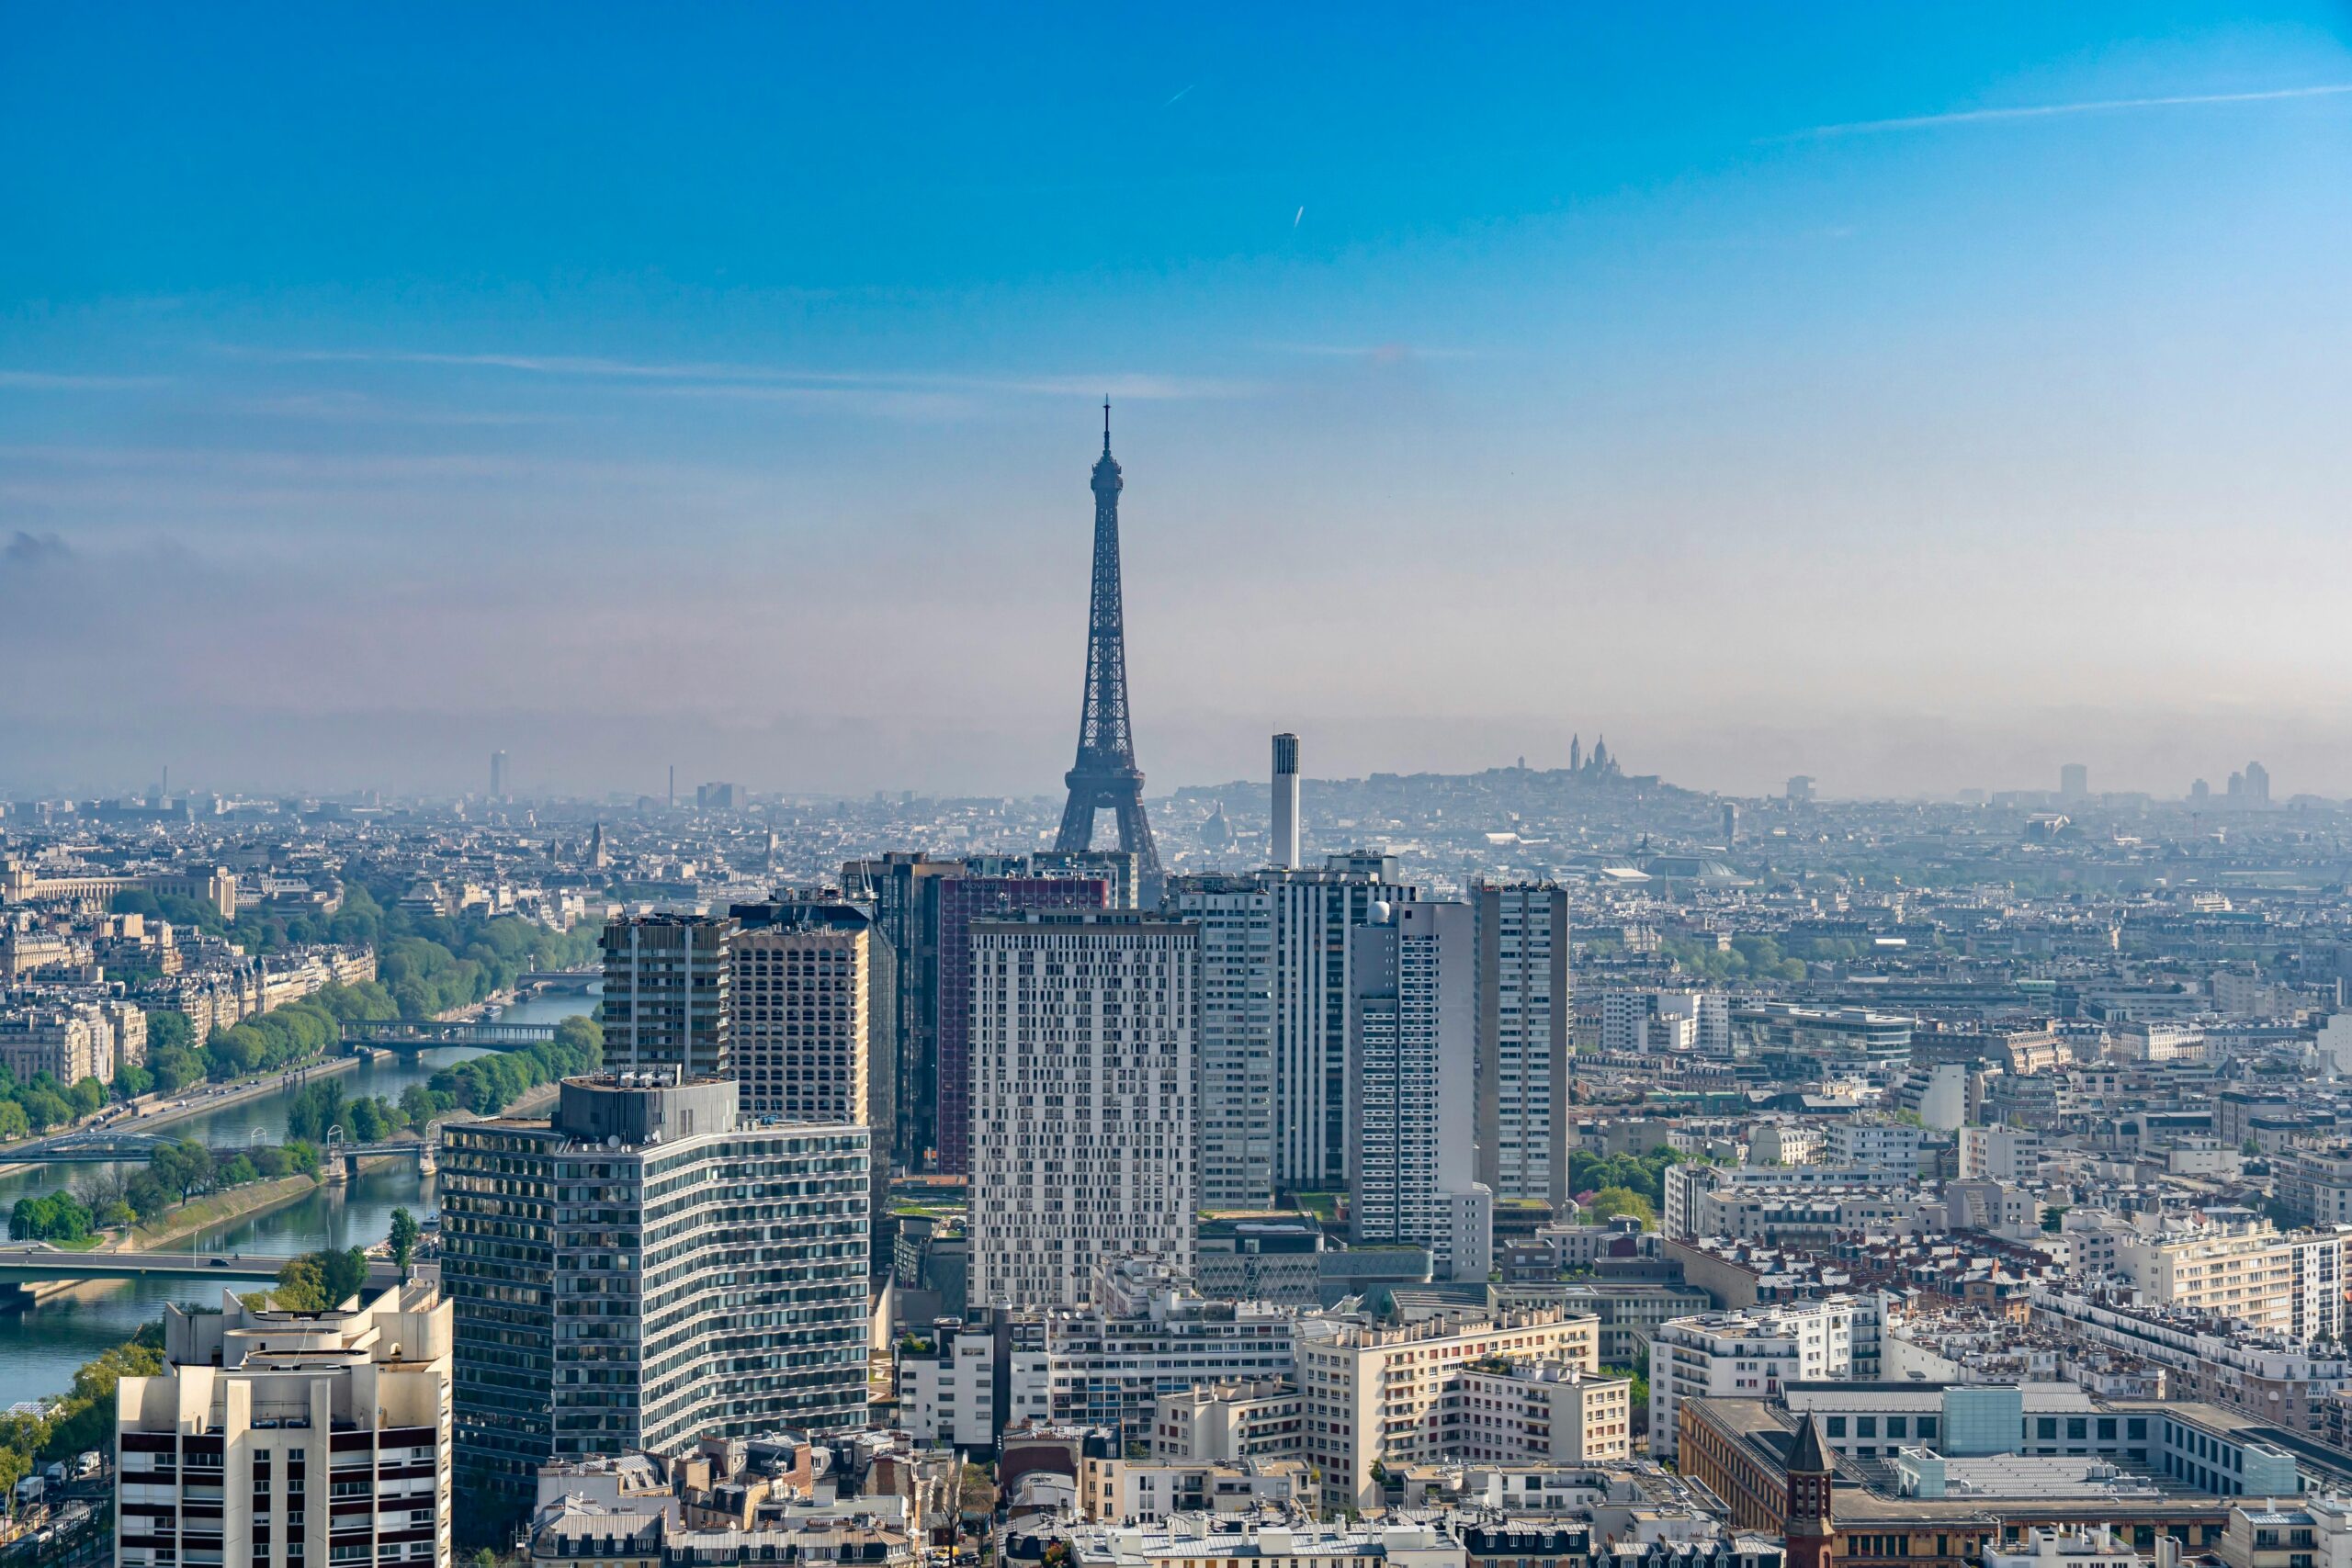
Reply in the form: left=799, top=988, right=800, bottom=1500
left=1265, top=853, right=1416, bottom=1192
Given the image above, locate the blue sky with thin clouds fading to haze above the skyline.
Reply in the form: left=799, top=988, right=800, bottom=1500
left=0, top=5, right=2352, bottom=795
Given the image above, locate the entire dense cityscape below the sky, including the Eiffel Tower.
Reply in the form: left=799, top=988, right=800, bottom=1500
left=0, top=409, right=2352, bottom=1568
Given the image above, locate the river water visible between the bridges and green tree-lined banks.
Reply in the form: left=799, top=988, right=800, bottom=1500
left=0, top=992, right=595, bottom=1411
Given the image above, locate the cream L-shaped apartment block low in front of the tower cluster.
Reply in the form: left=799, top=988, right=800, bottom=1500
left=1298, top=1312, right=1600, bottom=1509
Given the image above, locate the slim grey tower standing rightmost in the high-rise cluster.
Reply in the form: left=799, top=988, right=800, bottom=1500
left=1470, top=882, right=1576, bottom=1206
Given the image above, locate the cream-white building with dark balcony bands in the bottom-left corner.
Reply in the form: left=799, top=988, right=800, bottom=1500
left=113, top=1281, right=452, bottom=1568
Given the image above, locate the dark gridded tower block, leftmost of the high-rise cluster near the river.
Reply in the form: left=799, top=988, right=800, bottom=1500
left=602, top=915, right=736, bottom=1077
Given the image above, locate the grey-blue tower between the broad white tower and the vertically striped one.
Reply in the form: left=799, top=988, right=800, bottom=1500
left=1167, top=877, right=1275, bottom=1208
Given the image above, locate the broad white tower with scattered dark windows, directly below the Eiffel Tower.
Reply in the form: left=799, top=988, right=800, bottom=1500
left=971, top=909, right=1202, bottom=1307
